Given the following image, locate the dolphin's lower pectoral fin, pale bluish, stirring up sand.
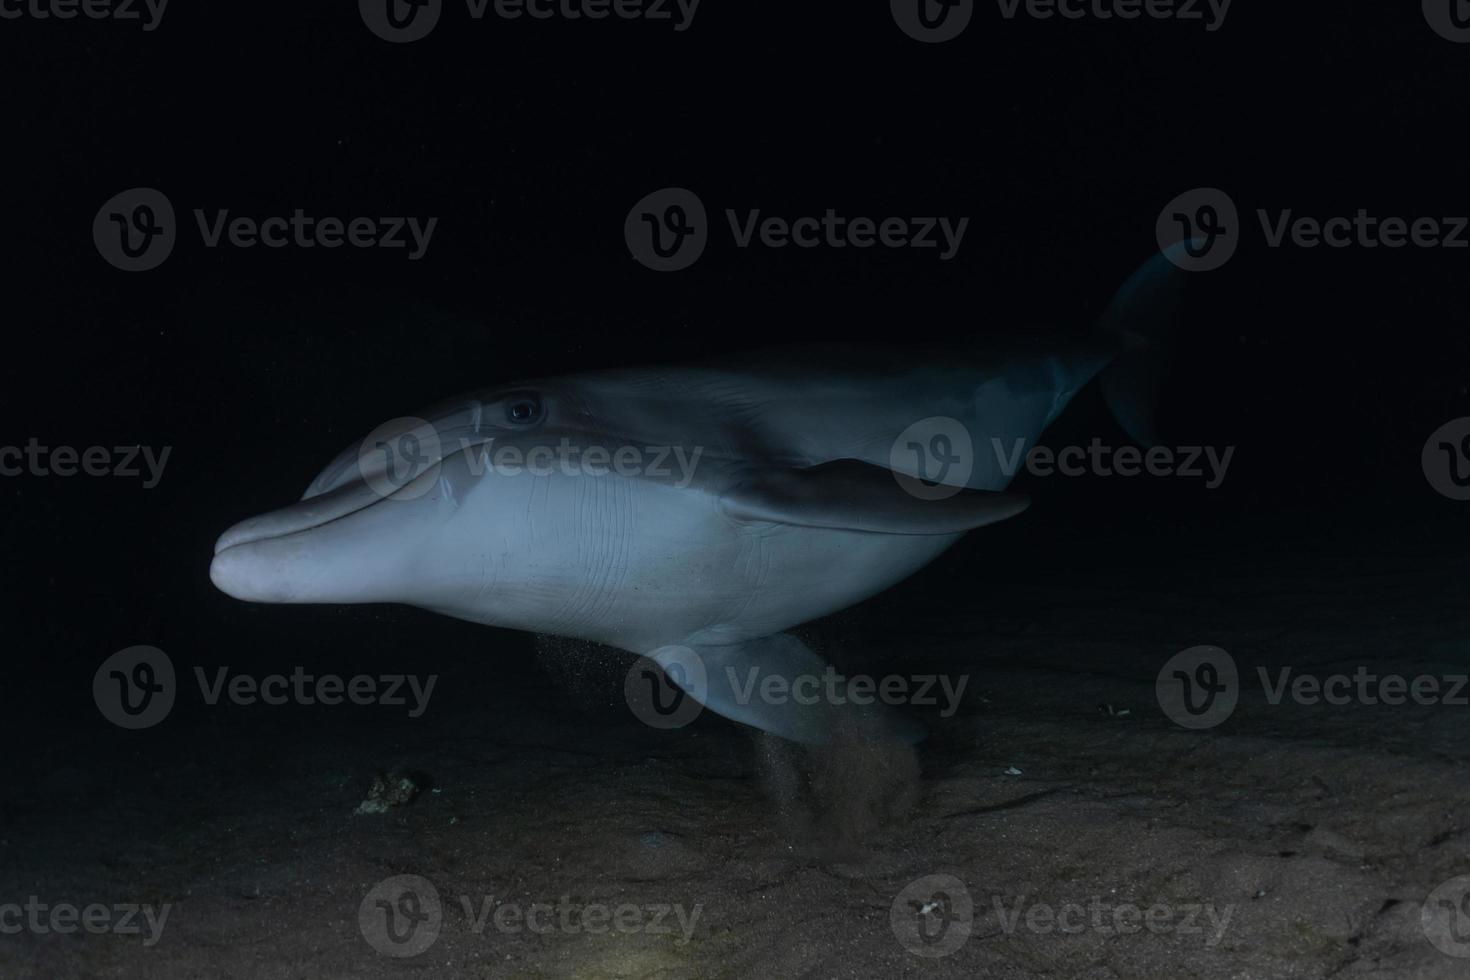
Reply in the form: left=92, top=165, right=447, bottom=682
left=653, top=633, right=928, bottom=745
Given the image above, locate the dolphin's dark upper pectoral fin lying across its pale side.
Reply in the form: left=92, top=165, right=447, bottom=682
left=720, top=460, right=1030, bottom=535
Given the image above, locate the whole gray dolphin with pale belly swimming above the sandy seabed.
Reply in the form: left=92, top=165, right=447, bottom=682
left=210, top=256, right=1179, bottom=743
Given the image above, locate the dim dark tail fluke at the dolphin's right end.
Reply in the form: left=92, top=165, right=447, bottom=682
left=1098, top=242, right=1186, bottom=445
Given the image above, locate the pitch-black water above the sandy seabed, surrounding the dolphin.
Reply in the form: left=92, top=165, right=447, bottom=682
left=0, top=0, right=1470, bottom=733
